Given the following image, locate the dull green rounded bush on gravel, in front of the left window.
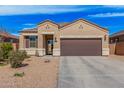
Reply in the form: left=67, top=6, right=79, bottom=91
left=9, top=51, right=27, bottom=68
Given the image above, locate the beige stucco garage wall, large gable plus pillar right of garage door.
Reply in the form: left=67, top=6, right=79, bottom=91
left=60, top=20, right=109, bottom=55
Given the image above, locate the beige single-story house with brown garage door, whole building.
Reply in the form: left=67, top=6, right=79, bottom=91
left=19, top=19, right=109, bottom=56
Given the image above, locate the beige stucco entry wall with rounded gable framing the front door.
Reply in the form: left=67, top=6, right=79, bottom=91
left=38, top=22, right=60, bottom=55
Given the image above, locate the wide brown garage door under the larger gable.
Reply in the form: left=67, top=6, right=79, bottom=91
left=61, top=38, right=102, bottom=56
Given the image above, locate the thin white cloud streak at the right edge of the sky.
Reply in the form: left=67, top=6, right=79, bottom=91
left=88, top=13, right=124, bottom=17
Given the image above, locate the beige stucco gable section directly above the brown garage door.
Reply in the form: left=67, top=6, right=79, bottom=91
left=60, top=21, right=108, bottom=41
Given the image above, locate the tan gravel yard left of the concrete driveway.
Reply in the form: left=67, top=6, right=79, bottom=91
left=0, top=56, right=59, bottom=88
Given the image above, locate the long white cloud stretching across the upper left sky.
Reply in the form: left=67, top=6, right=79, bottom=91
left=0, top=5, right=86, bottom=15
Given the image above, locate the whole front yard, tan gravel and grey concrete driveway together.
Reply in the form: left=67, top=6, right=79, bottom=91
left=0, top=55, right=124, bottom=88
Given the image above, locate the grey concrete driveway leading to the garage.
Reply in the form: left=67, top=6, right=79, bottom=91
left=58, top=56, right=124, bottom=88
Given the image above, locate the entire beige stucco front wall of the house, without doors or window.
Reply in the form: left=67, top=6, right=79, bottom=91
left=19, top=20, right=109, bottom=56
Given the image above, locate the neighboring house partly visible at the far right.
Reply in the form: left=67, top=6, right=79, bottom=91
left=109, top=30, right=124, bottom=55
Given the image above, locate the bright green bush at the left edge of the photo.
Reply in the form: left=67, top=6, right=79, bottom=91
left=0, top=43, right=13, bottom=59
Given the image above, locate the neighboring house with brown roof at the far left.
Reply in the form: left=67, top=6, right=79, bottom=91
left=0, top=31, right=19, bottom=50
